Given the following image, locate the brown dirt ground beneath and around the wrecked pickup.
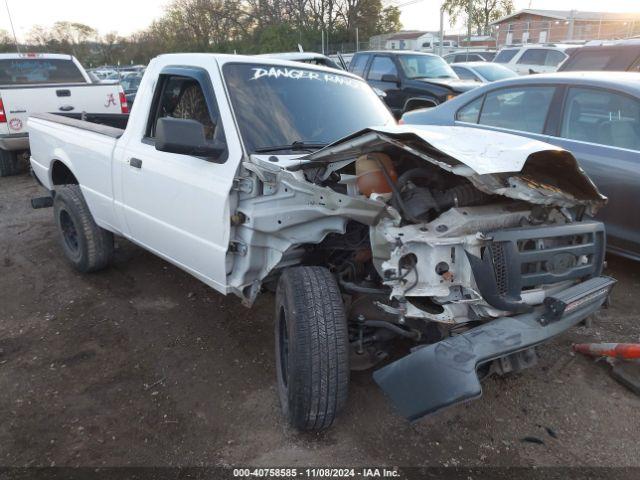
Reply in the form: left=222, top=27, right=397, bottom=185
left=0, top=174, right=640, bottom=466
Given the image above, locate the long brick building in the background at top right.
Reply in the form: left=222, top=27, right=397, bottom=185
left=491, top=9, right=640, bottom=47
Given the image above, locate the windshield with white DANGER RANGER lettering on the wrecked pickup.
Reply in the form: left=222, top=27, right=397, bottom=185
left=223, top=63, right=394, bottom=153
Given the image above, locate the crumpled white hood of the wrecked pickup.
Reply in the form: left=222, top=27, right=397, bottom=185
left=289, top=125, right=606, bottom=214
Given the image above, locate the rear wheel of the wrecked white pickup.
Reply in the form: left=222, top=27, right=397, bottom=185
left=53, top=185, right=113, bottom=272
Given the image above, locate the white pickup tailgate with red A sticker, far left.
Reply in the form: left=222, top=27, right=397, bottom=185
left=0, top=84, right=122, bottom=134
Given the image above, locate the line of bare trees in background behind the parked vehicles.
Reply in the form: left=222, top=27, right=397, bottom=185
left=0, top=0, right=402, bottom=66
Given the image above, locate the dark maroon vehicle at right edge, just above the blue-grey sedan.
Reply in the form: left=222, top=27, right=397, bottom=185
left=558, top=39, right=640, bottom=72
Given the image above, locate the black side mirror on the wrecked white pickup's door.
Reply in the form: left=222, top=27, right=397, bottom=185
left=156, top=117, right=225, bottom=161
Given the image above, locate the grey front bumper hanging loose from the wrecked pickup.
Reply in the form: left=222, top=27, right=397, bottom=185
left=373, top=276, right=615, bottom=420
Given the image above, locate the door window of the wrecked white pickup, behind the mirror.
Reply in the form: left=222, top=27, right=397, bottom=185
left=147, top=75, right=225, bottom=141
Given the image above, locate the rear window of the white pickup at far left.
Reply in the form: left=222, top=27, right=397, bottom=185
left=0, top=58, right=87, bottom=85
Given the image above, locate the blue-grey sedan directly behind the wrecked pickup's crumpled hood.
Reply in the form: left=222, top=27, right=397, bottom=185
left=403, top=72, right=640, bottom=260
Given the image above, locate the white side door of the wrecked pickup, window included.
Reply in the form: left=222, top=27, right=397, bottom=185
left=116, top=67, right=240, bottom=293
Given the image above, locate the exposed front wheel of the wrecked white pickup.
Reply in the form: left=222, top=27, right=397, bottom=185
left=275, top=267, right=349, bottom=430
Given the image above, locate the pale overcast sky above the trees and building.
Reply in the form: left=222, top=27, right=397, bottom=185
left=0, top=0, right=640, bottom=41
